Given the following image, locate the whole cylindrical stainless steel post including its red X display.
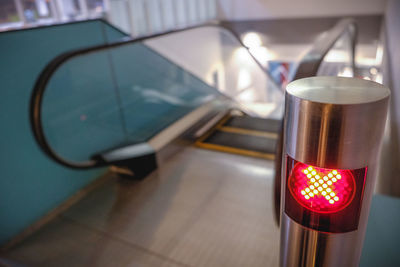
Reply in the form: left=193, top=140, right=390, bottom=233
left=280, top=77, right=390, bottom=267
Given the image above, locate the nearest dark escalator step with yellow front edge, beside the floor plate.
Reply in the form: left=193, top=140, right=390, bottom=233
left=197, top=130, right=276, bottom=159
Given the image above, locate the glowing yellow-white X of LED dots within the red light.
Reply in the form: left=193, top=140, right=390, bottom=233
left=301, top=166, right=342, bottom=204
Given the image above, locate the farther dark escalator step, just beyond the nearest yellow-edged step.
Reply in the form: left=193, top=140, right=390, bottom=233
left=224, top=116, right=282, bottom=133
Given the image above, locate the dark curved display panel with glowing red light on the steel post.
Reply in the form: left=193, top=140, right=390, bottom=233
left=285, top=156, right=367, bottom=233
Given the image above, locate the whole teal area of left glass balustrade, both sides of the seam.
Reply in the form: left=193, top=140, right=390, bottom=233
left=42, top=43, right=219, bottom=162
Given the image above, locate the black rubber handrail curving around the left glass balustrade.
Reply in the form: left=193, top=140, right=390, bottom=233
left=29, top=19, right=280, bottom=169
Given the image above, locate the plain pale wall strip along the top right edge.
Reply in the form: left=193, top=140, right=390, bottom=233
left=218, top=0, right=386, bottom=20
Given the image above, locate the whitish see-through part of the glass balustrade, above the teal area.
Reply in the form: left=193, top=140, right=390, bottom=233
left=146, top=27, right=283, bottom=118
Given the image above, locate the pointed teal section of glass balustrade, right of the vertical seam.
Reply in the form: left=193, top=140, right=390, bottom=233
left=111, top=44, right=218, bottom=142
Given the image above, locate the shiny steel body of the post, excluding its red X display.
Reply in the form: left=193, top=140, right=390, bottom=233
left=280, top=77, right=390, bottom=267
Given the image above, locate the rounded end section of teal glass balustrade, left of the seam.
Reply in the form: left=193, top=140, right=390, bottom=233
left=42, top=52, right=125, bottom=161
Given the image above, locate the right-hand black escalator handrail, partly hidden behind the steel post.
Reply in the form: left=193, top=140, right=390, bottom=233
left=274, top=18, right=357, bottom=225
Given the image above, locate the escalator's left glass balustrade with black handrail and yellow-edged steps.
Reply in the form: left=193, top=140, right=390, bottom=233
left=31, top=22, right=283, bottom=178
